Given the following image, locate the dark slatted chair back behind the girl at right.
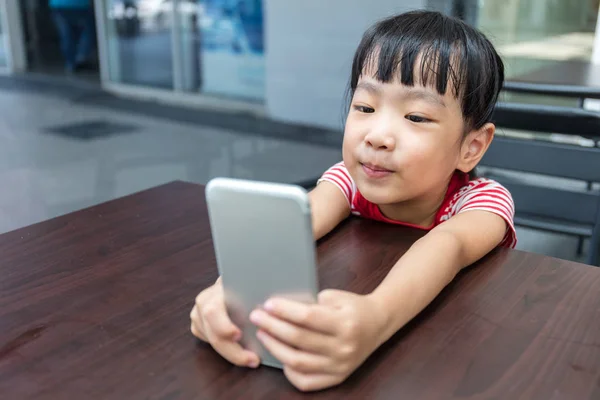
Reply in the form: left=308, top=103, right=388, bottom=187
left=480, top=103, right=600, bottom=265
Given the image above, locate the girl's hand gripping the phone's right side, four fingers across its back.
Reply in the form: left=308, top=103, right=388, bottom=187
left=250, top=290, right=386, bottom=391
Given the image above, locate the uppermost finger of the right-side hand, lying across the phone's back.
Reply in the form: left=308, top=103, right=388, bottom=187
left=263, top=298, right=337, bottom=335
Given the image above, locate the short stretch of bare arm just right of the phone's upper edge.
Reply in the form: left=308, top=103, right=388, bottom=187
left=309, top=181, right=350, bottom=240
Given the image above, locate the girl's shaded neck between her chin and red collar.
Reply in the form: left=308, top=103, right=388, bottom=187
left=379, top=178, right=448, bottom=228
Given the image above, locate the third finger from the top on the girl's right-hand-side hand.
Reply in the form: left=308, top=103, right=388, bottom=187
left=256, top=330, right=332, bottom=373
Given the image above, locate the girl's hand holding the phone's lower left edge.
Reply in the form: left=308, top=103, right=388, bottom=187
left=190, top=278, right=260, bottom=368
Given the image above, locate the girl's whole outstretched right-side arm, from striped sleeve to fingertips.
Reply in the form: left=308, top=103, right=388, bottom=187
left=250, top=210, right=506, bottom=391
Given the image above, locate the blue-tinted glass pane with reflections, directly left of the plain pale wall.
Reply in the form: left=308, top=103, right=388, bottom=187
left=178, top=0, right=265, bottom=100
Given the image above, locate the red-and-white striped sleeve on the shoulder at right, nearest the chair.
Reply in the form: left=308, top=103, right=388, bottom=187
left=456, top=179, right=517, bottom=248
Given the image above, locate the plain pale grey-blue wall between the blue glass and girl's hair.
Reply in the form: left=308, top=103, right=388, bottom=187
left=264, top=0, right=425, bottom=129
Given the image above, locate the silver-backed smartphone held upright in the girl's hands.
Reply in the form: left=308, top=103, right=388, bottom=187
left=206, top=178, right=318, bottom=368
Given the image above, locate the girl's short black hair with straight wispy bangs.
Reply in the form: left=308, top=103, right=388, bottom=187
left=349, top=11, right=504, bottom=132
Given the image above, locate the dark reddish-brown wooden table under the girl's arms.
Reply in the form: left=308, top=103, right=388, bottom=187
left=0, top=182, right=600, bottom=400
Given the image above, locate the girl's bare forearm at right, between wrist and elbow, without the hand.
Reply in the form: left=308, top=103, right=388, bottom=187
left=369, top=232, right=465, bottom=344
